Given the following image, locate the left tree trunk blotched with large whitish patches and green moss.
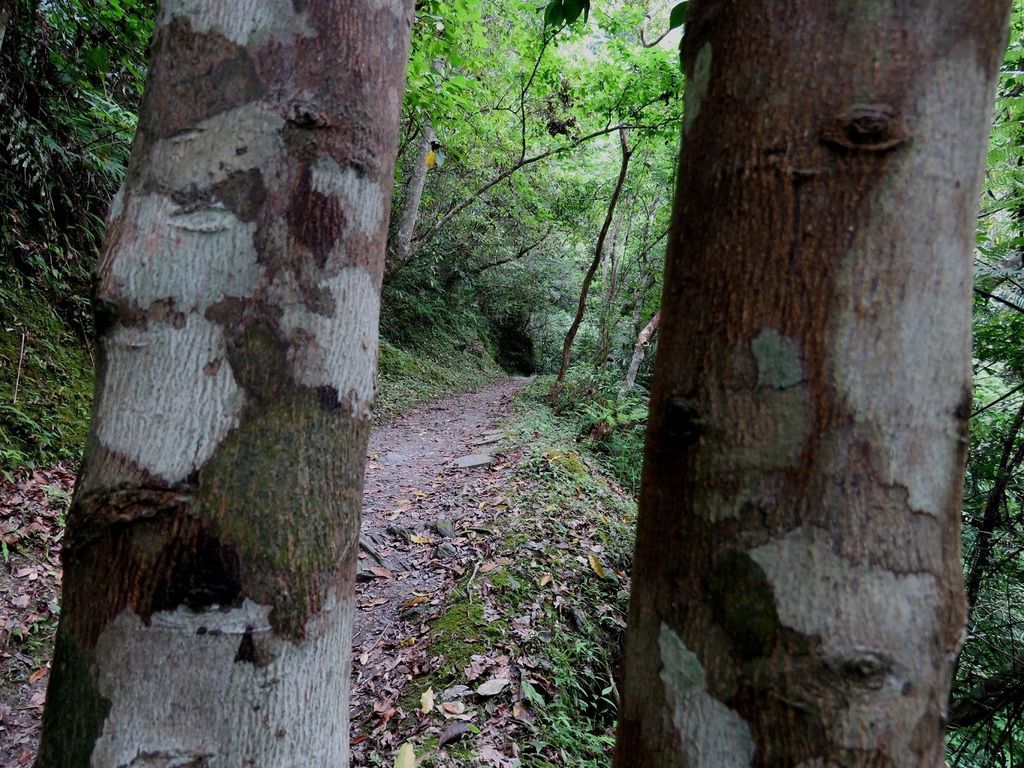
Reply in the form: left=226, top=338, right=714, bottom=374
left=37, top=0, right=412, bottom=768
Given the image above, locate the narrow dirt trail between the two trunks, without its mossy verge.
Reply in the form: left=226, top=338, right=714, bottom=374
left=351, top=379, right=528, bottom=765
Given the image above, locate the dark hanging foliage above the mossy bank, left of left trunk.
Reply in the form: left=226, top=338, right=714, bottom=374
left=0, top=0, right=156, bottom=325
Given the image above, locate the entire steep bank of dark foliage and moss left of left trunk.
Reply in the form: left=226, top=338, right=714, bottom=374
left=0, top=0, right=156, bottom=472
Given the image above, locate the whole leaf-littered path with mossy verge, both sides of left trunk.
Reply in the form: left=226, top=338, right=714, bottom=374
left=0, top=379, right=636, bottom=768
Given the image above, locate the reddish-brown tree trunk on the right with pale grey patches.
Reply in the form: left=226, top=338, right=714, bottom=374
left=616, top=0, right=1009, bottom=768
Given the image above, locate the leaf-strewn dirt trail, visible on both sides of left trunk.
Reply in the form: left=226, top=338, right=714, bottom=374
left=0, top=379, right=526, bottom=768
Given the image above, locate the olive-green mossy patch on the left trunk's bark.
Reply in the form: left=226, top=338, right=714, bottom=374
left=196, top=382, right=369, bottom=637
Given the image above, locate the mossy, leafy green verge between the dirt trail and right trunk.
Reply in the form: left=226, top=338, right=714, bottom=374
left=416, top=397, right=636, bottom=768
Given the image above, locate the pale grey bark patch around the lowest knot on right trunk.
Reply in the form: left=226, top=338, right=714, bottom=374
left=750, top=528, right=948, bottom=765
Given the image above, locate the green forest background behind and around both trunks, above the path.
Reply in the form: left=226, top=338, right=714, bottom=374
left=0, top=0, right=1024, bottom=766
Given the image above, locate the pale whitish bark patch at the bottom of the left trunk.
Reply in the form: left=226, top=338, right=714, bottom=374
left=89, top=600, right=352, bottom=768
